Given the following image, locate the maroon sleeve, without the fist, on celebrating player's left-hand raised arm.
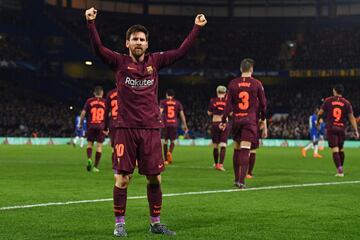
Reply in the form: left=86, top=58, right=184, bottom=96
left=88, top=20, right=122, bottom=70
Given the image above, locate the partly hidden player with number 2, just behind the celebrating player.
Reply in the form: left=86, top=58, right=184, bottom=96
left=105, top=88, right=118, bottom=168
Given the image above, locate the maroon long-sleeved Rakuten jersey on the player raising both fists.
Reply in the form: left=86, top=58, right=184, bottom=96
left=88, top=21, right=201, bottom=128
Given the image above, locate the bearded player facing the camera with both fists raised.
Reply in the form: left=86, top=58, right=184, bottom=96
left=85, top=8, right=207, bottom=237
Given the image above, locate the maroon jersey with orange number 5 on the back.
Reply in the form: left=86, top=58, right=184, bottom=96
left=160, top=99, right=183, bottom=127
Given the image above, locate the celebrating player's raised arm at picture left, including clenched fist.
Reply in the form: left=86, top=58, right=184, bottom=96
left=85, top=7, right=120, bottom=69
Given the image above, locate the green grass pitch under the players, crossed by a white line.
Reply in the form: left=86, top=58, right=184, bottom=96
left=0, top=145, right=360, bottom=240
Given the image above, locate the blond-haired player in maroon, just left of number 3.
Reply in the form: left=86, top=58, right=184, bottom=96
left=208, top=86, right=230, bottom=171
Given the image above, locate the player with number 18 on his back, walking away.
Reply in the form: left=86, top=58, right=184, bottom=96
left=80, top=86, right=105, bottom=172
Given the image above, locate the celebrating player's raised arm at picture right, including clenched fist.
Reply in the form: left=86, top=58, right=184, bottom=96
left=154, top=14, right=207, bottom=69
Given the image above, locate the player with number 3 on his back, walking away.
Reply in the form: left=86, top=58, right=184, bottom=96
left=220, top=58, right=266, bottom=189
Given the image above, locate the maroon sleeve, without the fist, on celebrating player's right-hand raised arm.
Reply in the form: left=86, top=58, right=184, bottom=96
left=153, top=25, right=201, bottom=69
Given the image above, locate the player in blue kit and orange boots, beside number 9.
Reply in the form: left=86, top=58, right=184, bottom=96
left=301, top=108, right=323, bottom=158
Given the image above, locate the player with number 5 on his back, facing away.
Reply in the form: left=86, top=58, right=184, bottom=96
left=160, top=89, right=189, bottom=164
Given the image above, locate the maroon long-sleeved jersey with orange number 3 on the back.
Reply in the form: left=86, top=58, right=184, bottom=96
left=223, top=77, right=266, bottom=125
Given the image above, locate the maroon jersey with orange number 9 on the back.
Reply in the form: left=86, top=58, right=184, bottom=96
left=321, top=96, right=353, bottom=130
